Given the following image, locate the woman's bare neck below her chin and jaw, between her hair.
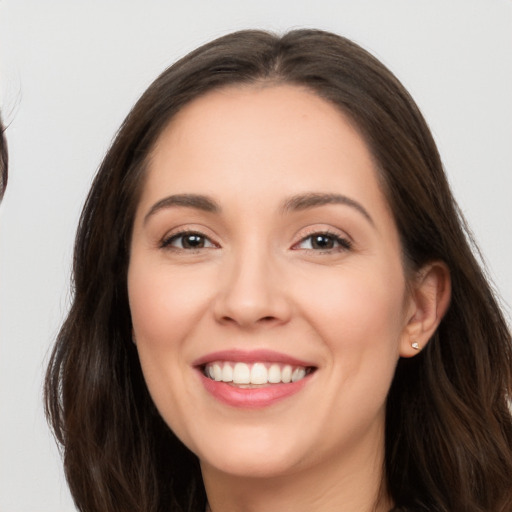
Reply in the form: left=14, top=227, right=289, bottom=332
left=201, top=426, right=392, bottom=512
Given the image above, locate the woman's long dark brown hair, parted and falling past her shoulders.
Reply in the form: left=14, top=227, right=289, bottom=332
left=45, top=30, right=512, bottom=512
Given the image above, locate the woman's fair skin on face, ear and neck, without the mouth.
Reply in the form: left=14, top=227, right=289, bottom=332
left=128, top=85, right=449, bottom=512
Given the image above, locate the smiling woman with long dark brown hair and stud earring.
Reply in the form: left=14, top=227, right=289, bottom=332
left=46, top=30, right=512, bottom=512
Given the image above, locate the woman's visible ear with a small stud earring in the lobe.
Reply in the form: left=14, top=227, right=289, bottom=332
left=400, top=261, right=451, bottom=357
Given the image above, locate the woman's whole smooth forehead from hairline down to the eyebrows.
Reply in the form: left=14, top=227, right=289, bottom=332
left=135, top=85, right=396, bottom=238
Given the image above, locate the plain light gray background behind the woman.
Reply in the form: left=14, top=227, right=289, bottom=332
left=0, top=0, right=512, bottom=512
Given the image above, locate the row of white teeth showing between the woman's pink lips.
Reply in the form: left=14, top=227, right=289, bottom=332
left=202, top=361, right=315, bottom=388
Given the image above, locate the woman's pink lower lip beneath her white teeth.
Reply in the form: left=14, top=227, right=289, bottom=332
left=200, top=372, right=309, bottom=409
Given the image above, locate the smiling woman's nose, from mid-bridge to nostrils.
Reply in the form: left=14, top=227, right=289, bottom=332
left=214, top=250, right=292, bottom=329
